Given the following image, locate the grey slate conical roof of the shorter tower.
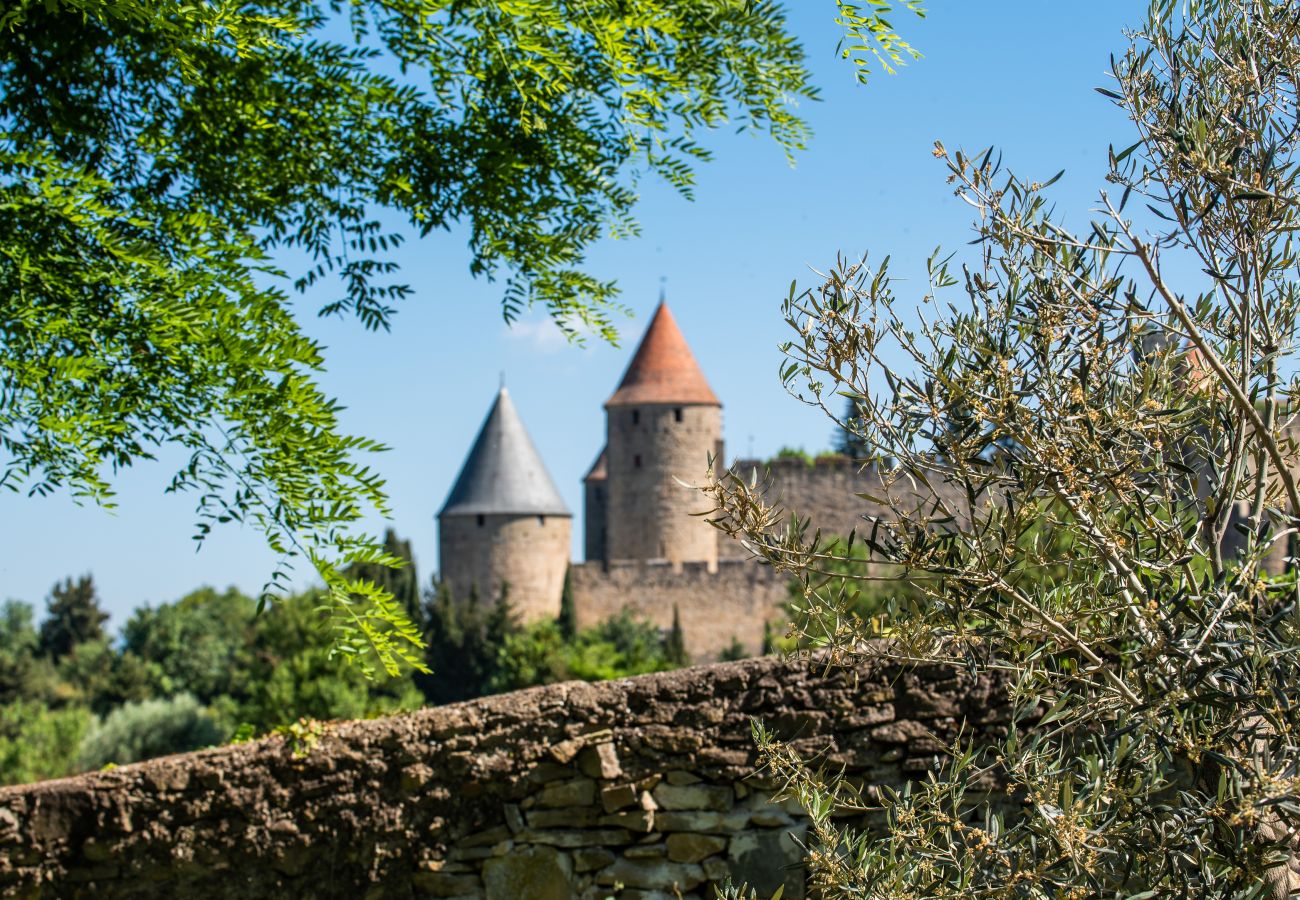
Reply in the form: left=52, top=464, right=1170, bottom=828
left=438, top=388, right=571, bottom=518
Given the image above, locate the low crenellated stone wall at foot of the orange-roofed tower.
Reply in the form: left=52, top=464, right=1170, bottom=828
left=569, top=556, right=789, bottom=662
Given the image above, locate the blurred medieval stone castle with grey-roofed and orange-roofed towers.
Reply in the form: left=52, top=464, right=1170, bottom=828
left=438, top=302, right=863, bottom=661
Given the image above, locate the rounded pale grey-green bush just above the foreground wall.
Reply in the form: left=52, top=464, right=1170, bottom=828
left=77, top=693, right=226, bottom=770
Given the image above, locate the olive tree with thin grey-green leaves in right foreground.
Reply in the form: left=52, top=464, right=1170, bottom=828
left=709, top=0, right=1300, bottom=897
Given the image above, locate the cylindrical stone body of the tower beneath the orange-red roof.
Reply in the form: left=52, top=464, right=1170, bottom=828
left=606, top=404, right=723, bottom=563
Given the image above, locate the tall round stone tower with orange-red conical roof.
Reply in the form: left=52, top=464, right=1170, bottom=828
left=598, top=300, right=723, bottom=568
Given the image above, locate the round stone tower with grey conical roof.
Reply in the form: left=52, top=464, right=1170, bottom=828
left=438, top=388, right=572, bottom=622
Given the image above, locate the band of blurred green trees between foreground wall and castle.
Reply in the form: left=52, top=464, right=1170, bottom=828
left=0, top=572, right=702, bottom=784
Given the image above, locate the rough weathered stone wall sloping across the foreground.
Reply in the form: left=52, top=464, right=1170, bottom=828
left=0, top=658, right=1000, bottom=900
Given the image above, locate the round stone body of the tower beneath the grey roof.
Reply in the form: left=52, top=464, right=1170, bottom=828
left=438, top=515, right=573, bottom=622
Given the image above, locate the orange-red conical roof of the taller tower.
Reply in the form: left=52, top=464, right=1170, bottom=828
left=605, top=300, right=722, bottom=407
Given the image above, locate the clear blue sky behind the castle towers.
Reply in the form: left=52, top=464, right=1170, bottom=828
left=0, top=0, right=1145, bottom=624
